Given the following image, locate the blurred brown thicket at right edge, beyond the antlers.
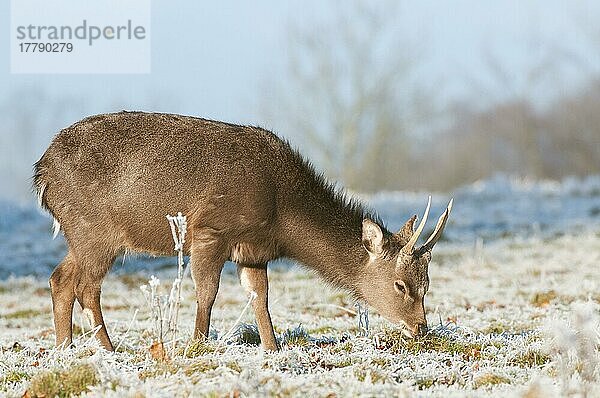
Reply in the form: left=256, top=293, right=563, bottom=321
left=427, top=81, right=600, bottom=189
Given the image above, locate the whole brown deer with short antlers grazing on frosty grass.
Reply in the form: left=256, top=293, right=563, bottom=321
left=34, top=112, right=452, bottom=350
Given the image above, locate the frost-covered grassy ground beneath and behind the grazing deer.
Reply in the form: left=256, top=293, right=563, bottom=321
left=0, top=177, right=600, bottom=397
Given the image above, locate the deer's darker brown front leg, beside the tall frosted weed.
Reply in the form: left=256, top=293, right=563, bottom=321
left=190, top=241, right=225, bottom=339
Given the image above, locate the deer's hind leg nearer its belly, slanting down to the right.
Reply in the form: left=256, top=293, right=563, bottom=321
left=75, top=252, right=115, bottom=351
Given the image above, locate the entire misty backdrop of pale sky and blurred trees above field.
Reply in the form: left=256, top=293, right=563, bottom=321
left=0, top=0, right=600, bottom=203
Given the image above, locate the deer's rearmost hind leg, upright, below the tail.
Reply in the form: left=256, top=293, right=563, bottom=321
left=49, top=251, right=79, bottom=347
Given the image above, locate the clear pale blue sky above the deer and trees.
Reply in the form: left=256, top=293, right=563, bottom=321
left=0, top=0, right=600, bottom=197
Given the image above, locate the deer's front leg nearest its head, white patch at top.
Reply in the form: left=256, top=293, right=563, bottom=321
left=238, top=264, right=278, bottom=351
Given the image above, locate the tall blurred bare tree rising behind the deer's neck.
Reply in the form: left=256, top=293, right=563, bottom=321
left=266, top=2, right=431, bottom=190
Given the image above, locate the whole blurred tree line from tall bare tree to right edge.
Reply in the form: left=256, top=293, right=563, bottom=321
left=265, top=2, right=600, bottom=191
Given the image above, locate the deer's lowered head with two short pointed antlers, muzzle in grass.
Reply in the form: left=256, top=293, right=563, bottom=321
left=359, top=197, right=453, bottom=337
